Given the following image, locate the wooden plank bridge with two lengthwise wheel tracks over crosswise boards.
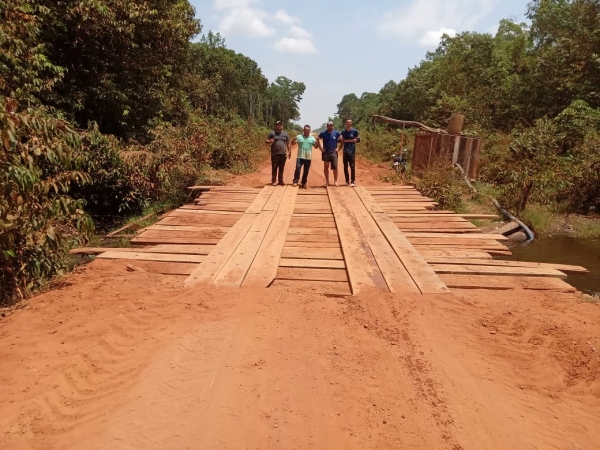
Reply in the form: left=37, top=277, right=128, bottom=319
left=81, top=185, right=585, bottom=295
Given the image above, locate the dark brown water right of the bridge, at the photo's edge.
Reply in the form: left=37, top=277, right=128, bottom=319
left=505, top=237, right=600, bottom=294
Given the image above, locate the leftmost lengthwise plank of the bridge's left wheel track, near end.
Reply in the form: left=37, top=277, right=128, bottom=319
left=184, top=214, right=258, bottom=287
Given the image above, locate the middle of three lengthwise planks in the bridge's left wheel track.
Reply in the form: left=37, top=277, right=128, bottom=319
left=212, top=209, right=276, bottom=287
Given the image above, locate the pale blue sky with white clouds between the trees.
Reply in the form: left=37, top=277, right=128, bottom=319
left=190, top=0, right=528, bottom=128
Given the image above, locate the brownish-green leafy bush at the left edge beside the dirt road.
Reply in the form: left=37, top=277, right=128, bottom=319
left=0, top=99, right=93, bottom=303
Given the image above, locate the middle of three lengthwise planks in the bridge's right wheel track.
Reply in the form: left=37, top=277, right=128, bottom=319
left=344, top=190, right=420, bottom=294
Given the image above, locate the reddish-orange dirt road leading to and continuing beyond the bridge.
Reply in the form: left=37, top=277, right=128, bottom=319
left=0, top=152, right=600, bottom=450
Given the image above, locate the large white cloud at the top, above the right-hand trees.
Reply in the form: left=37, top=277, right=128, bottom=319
left=379, top=0, right=497, bottom=47
